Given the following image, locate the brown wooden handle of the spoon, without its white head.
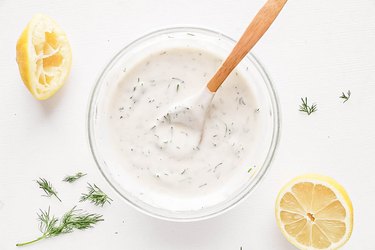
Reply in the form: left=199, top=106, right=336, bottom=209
left=207, top=0, right=287, bottom=92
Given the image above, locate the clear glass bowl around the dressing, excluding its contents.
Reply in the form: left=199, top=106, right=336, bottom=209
left=88, top=27, right=280, bottom=221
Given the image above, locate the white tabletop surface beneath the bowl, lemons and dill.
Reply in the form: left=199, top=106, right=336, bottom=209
left=0, top=0, right=375, bottom=250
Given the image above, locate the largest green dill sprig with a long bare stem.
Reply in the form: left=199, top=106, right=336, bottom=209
left=16, top=207, right=104, bottom=247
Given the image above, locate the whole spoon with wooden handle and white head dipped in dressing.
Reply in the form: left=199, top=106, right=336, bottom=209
left=156, top=0, right=287, bottom=155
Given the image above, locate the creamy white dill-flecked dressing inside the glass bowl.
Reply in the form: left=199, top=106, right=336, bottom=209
left=107, top=48, right=260, bottom=210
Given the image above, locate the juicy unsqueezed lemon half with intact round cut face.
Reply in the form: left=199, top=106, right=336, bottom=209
left=276, top=175, right=353, bottom=249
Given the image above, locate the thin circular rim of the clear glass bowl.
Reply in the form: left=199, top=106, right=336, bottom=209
left=87, top=27, right=281, bottom=222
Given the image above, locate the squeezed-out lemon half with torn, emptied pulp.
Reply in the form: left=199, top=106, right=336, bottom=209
left=16, top=14, right=72, bottom=100
